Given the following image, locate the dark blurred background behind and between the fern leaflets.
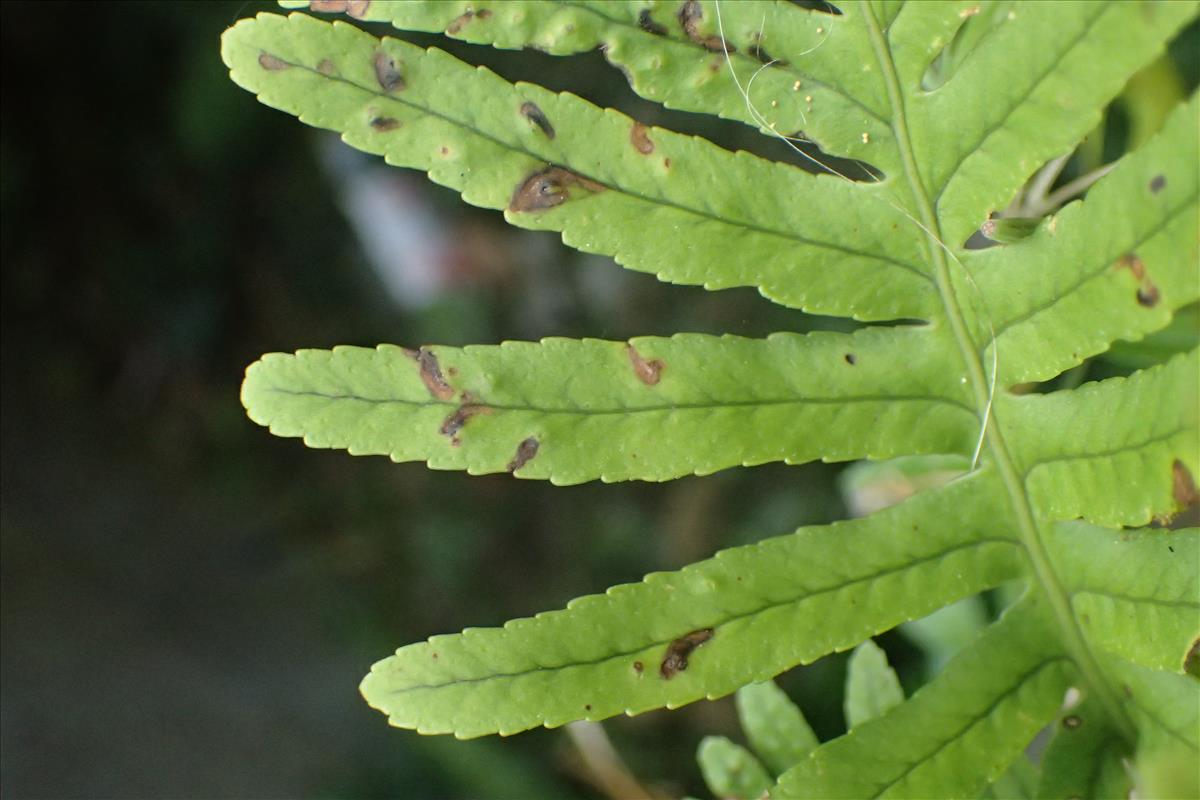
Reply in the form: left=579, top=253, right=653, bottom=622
left=0, top=2, right=1194, bottom=798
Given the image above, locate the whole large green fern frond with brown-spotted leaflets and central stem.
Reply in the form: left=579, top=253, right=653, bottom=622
left=222, top=0, right=1200, bottom=798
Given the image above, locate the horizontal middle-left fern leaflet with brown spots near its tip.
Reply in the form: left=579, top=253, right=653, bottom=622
left=242, top=329, right=976, bottom=483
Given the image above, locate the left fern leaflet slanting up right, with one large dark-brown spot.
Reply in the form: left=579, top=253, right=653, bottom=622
left=362, top=475, right=1019, bottom=738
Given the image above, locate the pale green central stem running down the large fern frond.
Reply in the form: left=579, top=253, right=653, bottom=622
left=859, top=0, right=1136, bottom=744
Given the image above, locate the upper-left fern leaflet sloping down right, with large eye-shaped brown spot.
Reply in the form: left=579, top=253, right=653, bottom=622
left=222, top=14, right=937, bottom=319
